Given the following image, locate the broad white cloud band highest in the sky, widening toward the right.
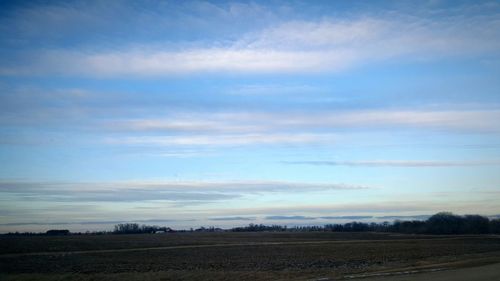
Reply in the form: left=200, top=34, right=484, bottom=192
left=0, top=15, right=500, bottom=76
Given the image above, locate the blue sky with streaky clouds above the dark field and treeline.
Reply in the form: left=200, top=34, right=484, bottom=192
left=0, top=0, right=500, bottom=232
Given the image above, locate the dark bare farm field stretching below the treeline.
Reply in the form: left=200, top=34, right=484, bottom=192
left=0, top=232, right=500, bottom=281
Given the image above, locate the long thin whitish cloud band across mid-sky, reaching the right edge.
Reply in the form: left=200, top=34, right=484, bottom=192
left=106, top=109, right=500, bottom=135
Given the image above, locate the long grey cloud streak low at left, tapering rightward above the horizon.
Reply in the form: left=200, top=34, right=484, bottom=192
left=0, top=181, right=368, bottom=204
